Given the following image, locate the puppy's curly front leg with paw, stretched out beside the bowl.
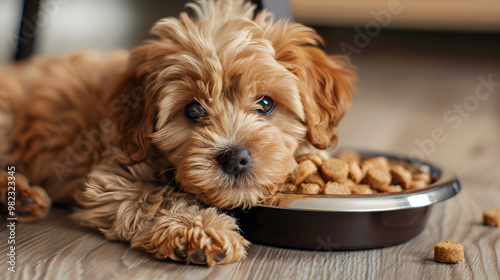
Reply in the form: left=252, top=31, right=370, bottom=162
left=74, top=161, right=249, bottom=266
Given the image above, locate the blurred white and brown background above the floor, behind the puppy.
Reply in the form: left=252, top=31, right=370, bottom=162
left=0, top=0, right=500, bottom=63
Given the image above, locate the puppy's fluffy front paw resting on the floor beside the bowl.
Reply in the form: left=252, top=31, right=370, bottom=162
left=132, top=206, right=250, bottom=266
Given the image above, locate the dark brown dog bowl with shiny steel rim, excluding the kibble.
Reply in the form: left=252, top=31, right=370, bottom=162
left=230, top=151, right=460, bottom=251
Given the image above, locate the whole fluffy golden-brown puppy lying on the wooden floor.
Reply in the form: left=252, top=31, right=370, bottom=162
left=0, top=0, right=354, bottom=266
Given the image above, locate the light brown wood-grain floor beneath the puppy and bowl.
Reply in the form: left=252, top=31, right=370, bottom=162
left=0, top=29, right=500, bottom=280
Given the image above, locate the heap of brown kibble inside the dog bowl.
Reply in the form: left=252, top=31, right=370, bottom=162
left=279, top=151, right=432, bottom=195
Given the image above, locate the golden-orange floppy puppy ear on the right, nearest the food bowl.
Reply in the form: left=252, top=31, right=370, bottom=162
left=264, top=21, right=356, bottom=149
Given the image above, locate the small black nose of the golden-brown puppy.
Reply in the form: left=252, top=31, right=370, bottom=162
left=217, top=146, right=250, bottom=176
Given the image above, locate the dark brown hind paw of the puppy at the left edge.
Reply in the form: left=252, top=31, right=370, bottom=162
left=0, top=170, right=51, bottom=222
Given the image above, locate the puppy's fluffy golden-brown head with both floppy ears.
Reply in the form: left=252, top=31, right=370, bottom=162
left=107, top=1, right=353, bottom=207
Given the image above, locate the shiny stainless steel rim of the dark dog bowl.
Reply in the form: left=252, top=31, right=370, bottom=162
left=258, top=150, right=461, bottom=212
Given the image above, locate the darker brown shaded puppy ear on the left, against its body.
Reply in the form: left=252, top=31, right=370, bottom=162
left=107, top=45, right=158, bottom=165
